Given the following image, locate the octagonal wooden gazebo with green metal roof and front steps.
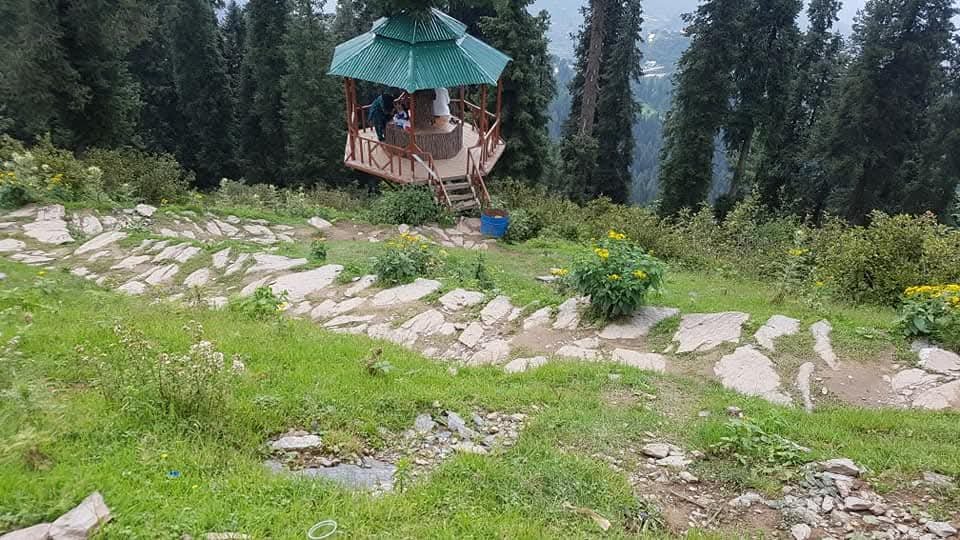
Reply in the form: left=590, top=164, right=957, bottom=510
left=330, top=9, right=510, bottom=211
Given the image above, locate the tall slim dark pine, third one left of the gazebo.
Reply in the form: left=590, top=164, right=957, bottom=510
left=169, top=0, right=234, bottom=186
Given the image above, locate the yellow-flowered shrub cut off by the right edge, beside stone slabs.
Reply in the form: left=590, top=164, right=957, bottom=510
left=898, top=283, right=960, bottom=349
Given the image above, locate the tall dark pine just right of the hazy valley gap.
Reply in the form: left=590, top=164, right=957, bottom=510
left=660, top=0, right=740, bottom=214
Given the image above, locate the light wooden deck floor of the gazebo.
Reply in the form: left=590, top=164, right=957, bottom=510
left=344, top=123, right=505, bottom=185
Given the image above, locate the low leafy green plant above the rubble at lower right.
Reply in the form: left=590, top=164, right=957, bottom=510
left=710, top=418, right=810, bottom=470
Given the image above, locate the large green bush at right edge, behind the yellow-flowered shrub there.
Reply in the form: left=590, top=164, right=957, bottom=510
left=814, top=212, right=960, bottom=305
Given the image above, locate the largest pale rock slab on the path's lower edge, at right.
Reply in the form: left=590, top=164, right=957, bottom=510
left=713, top=345, right=791, bottom=404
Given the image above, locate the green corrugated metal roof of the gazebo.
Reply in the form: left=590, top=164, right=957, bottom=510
left=330, top=9, right=510, bottom=92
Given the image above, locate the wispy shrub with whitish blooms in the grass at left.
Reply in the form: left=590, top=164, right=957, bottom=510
left=77, top=321, right=245, bottom=417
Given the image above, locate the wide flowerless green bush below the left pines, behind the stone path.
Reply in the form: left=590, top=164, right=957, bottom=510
left=83, top=148, right=193, bottom=204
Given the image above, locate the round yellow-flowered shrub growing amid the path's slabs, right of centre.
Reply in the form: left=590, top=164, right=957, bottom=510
left=572, top=230, right=664, bottom=319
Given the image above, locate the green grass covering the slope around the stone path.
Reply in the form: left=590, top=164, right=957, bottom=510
left=0, top=228, right=960, bottom=539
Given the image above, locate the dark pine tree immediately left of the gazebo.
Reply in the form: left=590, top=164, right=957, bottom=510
left=283, top=0, right=346, bottom=182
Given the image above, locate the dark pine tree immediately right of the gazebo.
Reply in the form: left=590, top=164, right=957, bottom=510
left=480, top=0, right=556, bottom=183
